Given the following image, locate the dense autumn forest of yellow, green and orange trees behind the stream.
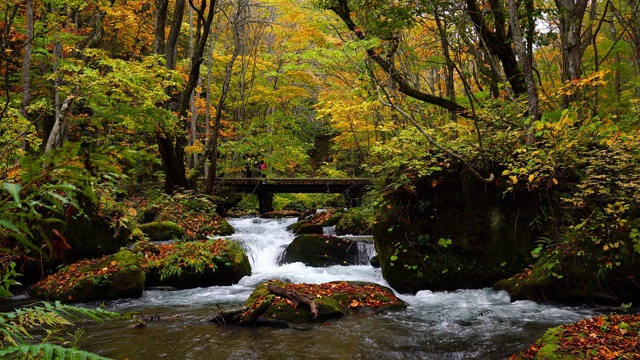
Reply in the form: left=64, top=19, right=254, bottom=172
left=0, top=0, right=640, bottom=296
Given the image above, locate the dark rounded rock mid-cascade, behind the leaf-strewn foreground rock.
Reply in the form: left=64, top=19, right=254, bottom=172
left=280, top=235, right=358, bottom=267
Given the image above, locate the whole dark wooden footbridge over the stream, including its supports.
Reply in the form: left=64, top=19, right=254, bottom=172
left=216, top=177, right=373, bottom=213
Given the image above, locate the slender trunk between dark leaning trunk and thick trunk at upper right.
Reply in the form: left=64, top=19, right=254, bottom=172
left=507, top=0, right=539, bottom=144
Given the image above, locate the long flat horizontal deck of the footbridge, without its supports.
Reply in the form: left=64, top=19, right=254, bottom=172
left=216, top=178, right=373, bottom=193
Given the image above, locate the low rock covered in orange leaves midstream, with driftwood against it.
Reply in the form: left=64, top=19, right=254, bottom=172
left=245, top=280, right=406, bottom=323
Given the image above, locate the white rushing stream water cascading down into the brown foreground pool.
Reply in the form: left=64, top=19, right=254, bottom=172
left=79, top=218, right=607, bottom=359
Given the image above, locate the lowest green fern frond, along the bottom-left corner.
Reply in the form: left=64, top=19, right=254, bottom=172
left=0, top=344, right=109, bottom=360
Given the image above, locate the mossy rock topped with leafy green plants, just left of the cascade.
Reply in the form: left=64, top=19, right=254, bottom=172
left=140, top=239, right=251, bottom=289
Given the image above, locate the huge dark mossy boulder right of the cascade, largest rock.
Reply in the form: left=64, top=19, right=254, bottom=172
left=372, top=173, right=546, bottom=293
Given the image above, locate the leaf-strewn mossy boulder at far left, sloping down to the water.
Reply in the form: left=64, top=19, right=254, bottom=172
left=32, top=250, right=145, bottom=303
